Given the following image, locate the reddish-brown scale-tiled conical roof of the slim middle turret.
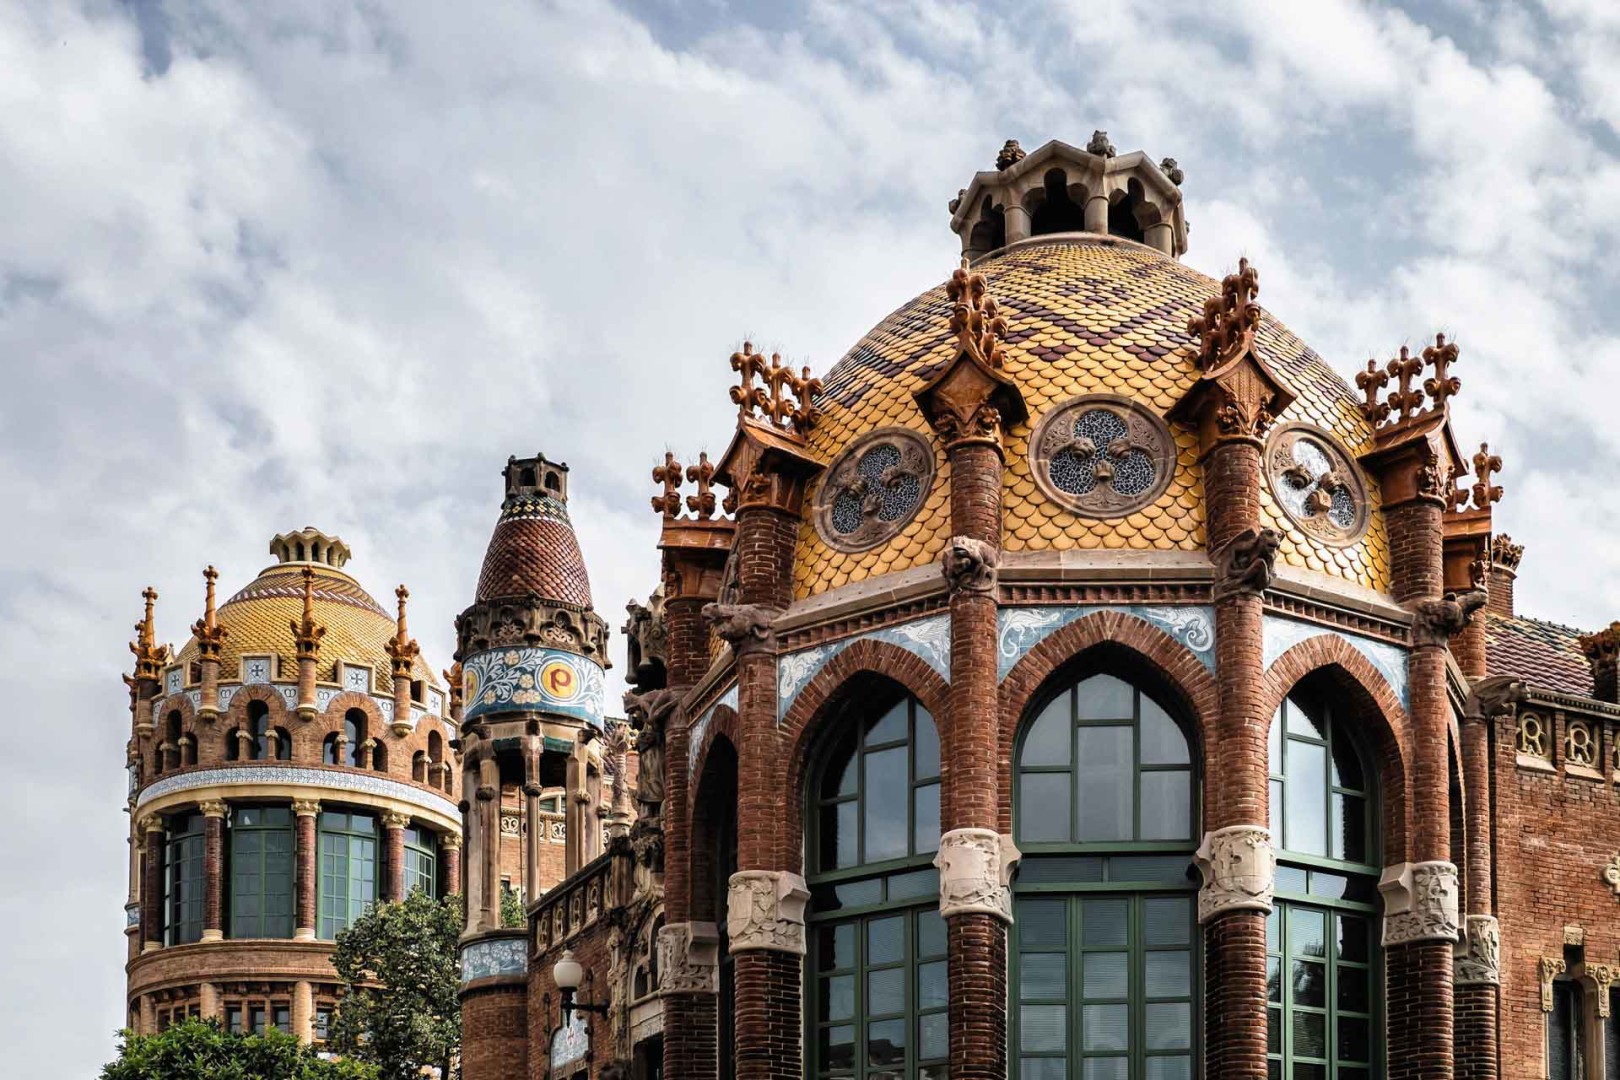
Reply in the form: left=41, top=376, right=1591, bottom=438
left=476, top=494, right=591, bottom=609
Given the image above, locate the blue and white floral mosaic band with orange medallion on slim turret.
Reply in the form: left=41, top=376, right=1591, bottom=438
left=462, top=646, right=606, bottom=729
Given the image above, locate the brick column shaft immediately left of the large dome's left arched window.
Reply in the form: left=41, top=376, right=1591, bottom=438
left=732, top=507, right=804, bottom=1080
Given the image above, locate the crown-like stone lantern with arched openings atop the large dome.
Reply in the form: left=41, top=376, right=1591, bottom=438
left=951, top=131, right=1187, bottom=259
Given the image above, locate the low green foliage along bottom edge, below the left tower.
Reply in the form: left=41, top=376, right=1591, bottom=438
left=100, top=1020, right=377, bottom=1080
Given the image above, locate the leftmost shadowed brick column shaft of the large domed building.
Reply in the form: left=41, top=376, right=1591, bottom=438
left=663, top=595, right=719, bottom=1080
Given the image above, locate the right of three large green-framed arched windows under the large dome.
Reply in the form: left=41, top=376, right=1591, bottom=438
left=1265, top=680, right=1383, bottom=1080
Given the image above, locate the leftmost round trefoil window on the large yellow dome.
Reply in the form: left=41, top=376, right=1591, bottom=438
left=815, top=427, right=933, bottom=552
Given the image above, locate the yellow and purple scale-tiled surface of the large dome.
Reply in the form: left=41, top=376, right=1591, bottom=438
left=795, top=235, right=1388, bottom=596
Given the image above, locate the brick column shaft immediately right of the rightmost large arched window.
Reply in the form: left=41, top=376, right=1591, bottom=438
left=1385, top=499, right=1455, bottom=1080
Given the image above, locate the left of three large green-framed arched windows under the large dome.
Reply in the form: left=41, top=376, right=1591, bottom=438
left=805, top=678, right=949, bottom=1080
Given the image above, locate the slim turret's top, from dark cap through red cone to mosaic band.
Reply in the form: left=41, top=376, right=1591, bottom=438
left=455, top=455, right=608, bottom=730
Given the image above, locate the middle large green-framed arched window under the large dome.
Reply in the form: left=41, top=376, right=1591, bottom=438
left=1009, top=667, right=1200, bottom=1080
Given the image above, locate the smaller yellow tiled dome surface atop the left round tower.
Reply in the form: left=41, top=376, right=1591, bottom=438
left=180, top=562, right=441, bottom=695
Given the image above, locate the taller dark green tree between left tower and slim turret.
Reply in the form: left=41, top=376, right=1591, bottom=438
left=329, top=889, right=462, bottom=1080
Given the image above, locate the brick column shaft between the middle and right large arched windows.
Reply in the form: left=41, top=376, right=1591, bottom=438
left=1204, top=440, right=1278, bottom=1080
